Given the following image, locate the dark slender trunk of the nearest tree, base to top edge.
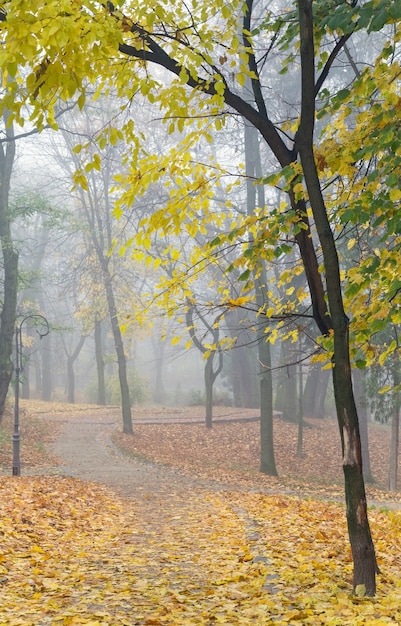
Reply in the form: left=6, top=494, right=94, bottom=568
left=297, top=0, right=378, bottom=596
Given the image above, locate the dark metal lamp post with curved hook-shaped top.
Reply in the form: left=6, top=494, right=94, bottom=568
left=13, top=313, right=50, bottom=476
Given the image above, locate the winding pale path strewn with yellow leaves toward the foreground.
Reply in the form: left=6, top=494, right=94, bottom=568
left=48, top=414, right=274, bottom=626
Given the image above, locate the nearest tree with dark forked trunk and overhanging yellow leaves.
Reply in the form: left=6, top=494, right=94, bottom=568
left=0, top=0, right=401, bottom=595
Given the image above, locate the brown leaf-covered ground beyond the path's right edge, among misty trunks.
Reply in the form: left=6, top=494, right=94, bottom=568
left=114, top=407, right=401, bottom=501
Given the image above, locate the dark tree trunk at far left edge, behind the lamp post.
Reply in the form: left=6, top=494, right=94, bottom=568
left=0, top=113, right=18, bottom=418
